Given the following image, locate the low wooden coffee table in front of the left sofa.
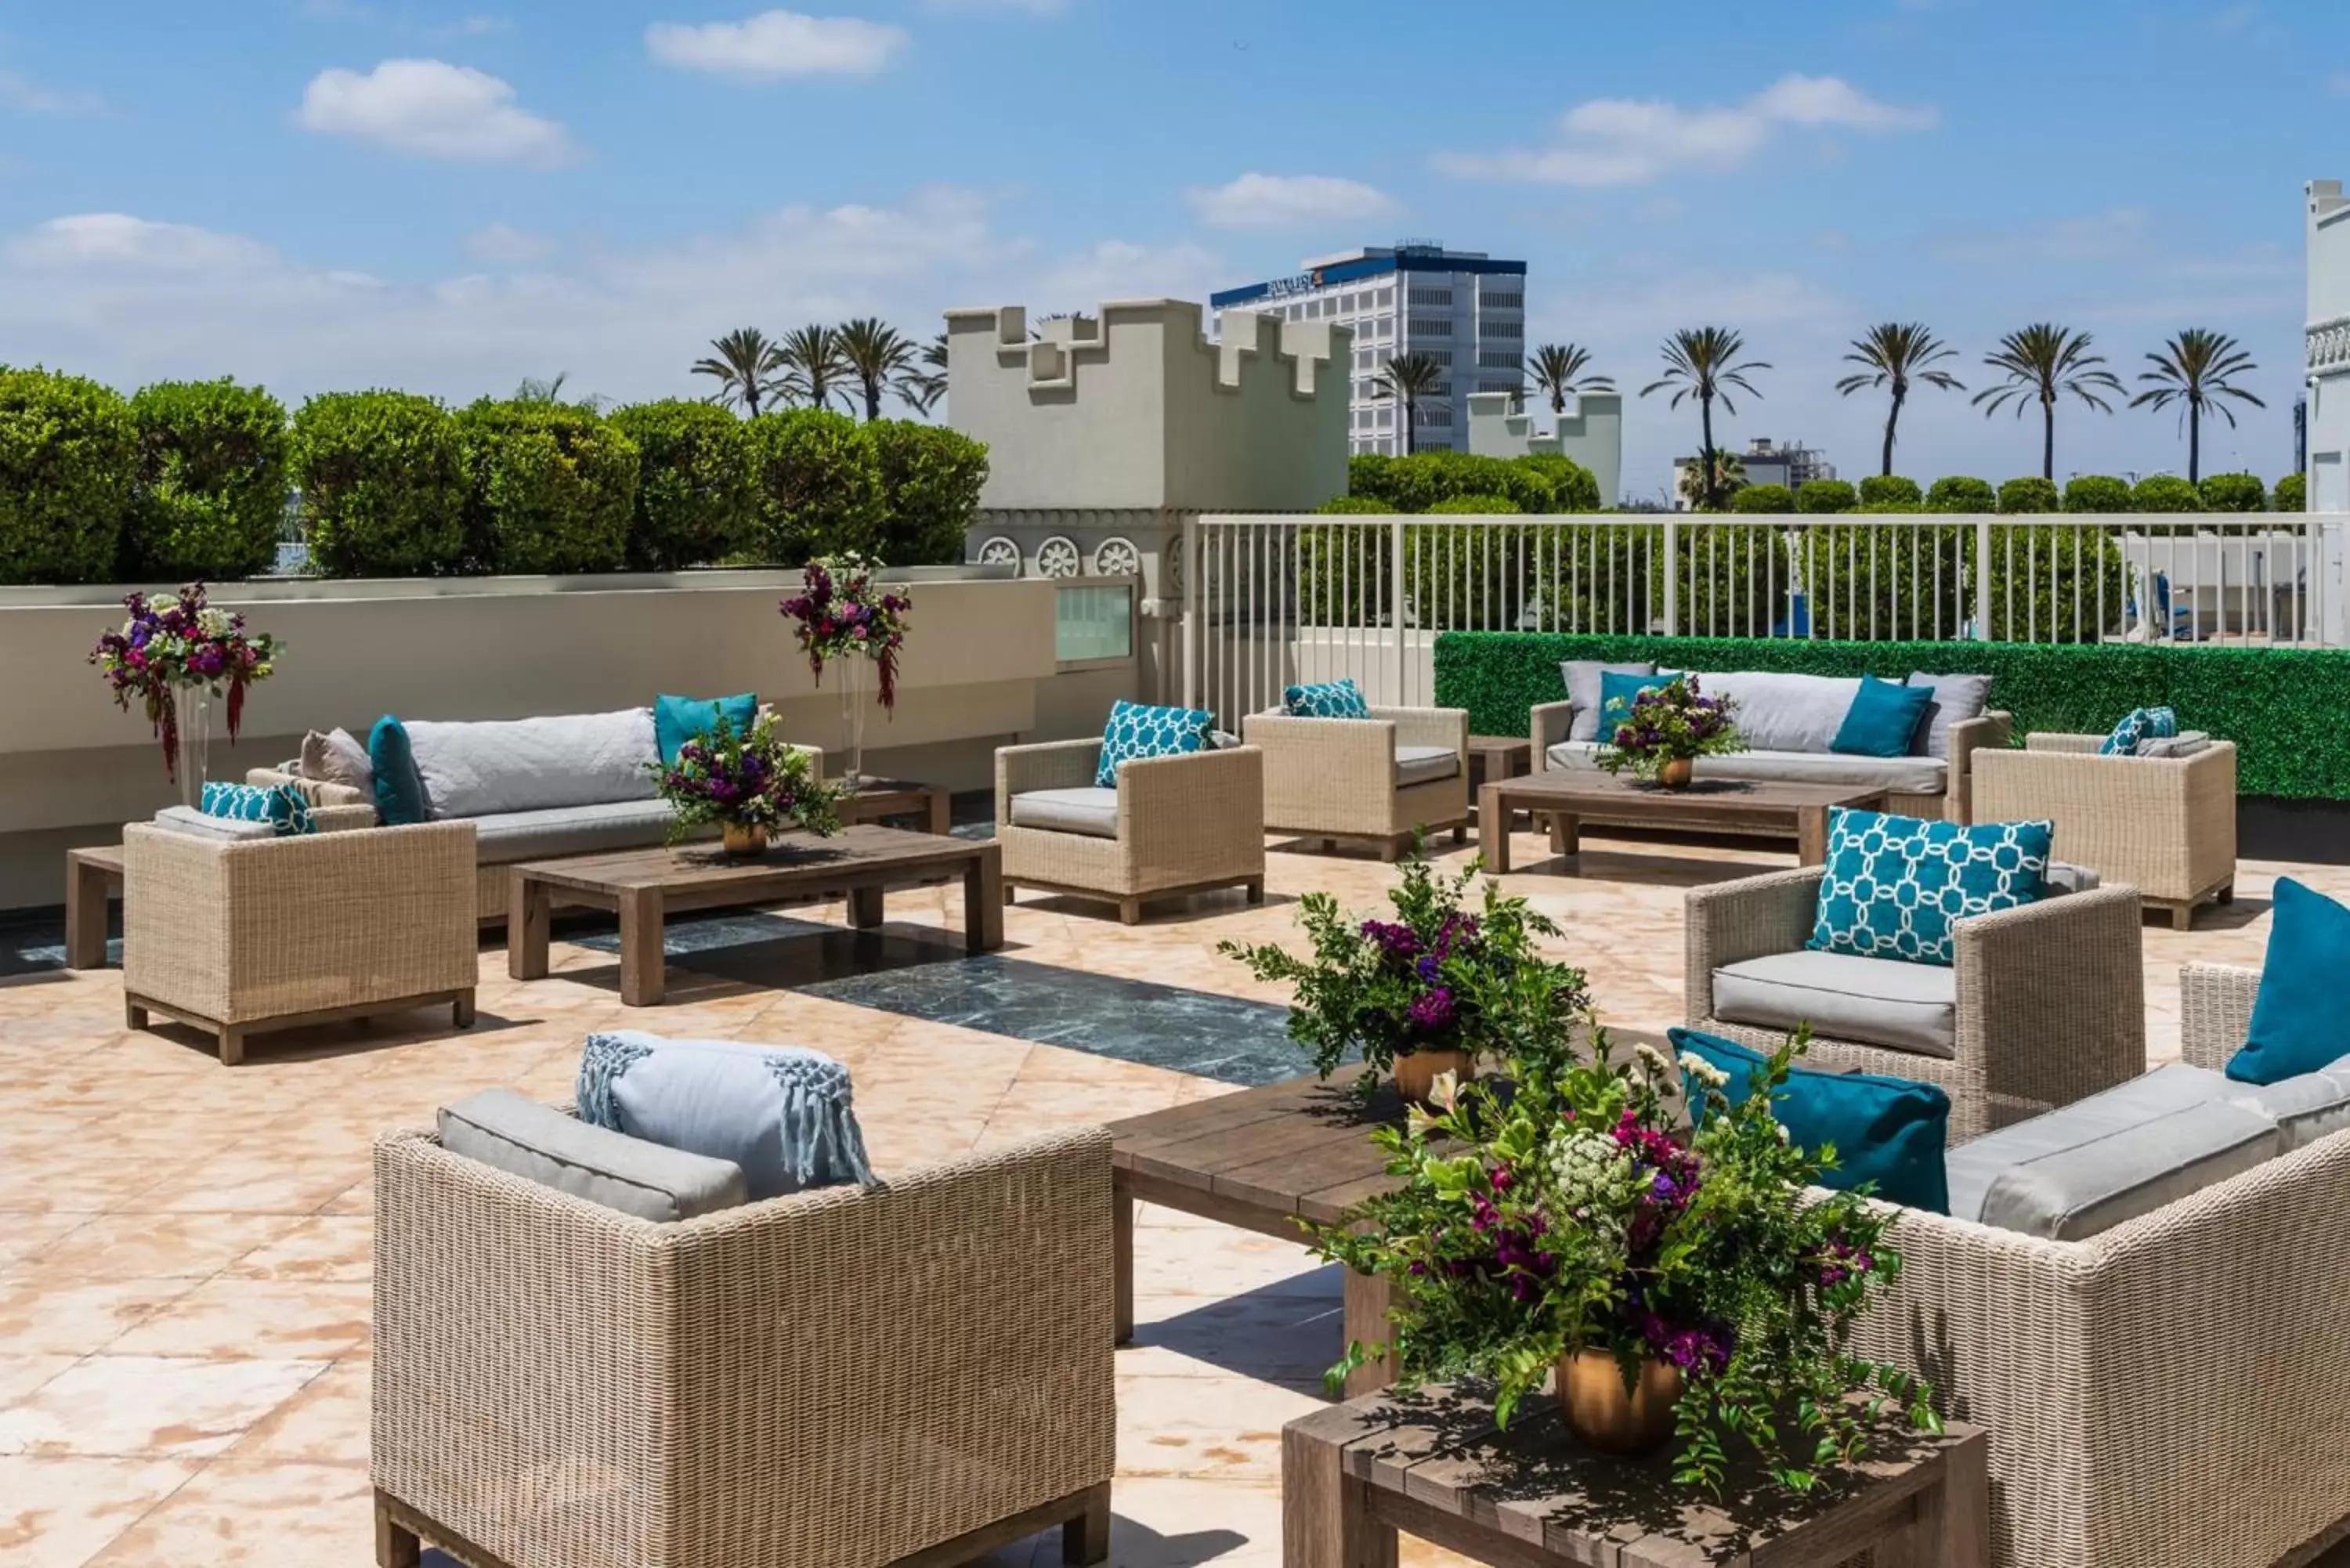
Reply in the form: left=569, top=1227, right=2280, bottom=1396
left=505, top=826, right=1003, bottom=1006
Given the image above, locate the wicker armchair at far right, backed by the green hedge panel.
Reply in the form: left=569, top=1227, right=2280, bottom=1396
left=1974, top=733, right=2235, bottom=931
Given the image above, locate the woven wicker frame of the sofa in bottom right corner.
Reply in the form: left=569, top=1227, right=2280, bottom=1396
left=1854, top=969, right=2350, bottom=1568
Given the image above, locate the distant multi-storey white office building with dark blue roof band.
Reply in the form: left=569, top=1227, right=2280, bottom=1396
left=1210, top=240, right=1525, bottom=453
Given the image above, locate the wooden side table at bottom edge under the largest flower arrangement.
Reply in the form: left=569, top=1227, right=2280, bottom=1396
left=1281, top=1387, right=1990, bottom=1568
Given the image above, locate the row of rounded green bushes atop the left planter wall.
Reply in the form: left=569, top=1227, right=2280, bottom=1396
left=0, top=367, right=987, bottom=585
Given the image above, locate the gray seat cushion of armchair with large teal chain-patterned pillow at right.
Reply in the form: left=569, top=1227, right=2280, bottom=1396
left=1713, top=952, right=1958, bottom=1060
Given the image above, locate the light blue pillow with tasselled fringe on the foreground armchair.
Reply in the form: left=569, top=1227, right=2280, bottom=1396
left=578, top=1030, right=879, bottom=1199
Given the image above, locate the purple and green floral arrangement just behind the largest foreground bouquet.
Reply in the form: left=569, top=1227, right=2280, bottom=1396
left=1217, top=849, right=1589, bottom=1089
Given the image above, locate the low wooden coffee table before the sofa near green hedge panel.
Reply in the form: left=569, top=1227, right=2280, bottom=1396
left=1478, top=768, right=1885, bottom=875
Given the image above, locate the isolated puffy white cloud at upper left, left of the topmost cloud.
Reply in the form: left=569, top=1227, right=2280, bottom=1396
left=296, top=59, right=578, bottom=167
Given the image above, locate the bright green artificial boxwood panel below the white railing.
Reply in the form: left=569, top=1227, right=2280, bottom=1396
left=1436, top=632, right=2350, bottom=800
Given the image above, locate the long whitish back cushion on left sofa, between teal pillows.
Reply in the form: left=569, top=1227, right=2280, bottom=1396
left=407, top=707, right=660, bottom=821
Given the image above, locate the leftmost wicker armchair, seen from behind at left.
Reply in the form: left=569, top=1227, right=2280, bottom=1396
left=122, top=823, right=477, bottom=1068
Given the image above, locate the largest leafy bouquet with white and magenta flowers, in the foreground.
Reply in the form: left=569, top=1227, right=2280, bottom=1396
left=1314, top=1030, right=1939, bottom=1493
